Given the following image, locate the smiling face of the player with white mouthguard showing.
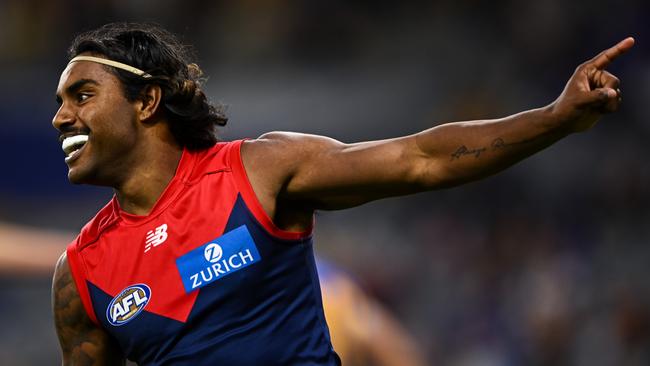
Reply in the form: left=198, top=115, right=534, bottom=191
left=52, top=61, right=139, bottom=187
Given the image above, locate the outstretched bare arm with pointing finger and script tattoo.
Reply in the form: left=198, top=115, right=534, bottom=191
left=242, top=38, right=634, bottom=217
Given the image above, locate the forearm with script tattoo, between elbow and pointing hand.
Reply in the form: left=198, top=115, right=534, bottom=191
left=414, top=107, right=569, bottom=189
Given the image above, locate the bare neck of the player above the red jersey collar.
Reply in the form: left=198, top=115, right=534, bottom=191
left=115, top=145, right=183, bottom=215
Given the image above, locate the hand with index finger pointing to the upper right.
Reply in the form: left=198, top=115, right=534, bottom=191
left=549, top=37, right=634, bottom=132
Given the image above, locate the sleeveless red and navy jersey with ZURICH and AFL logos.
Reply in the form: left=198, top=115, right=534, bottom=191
left=67, top=141, right=340, bottom=365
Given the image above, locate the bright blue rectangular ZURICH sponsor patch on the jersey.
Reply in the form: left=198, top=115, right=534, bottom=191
left=176, top=225, right=262, bottom=293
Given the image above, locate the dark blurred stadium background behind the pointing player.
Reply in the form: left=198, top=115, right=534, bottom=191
left=0, top=0, right=650, bottom=366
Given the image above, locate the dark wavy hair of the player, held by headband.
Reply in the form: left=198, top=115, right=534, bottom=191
left=68, top=23, right=228, bottom=150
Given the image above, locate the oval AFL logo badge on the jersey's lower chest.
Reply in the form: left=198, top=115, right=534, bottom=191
left=106, top=283, right=151, bottom=326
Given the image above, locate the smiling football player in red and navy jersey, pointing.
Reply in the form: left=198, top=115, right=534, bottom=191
left=53, top=24, right=634, bottom=365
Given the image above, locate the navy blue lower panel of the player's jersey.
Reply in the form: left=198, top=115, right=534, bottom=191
left=89, top=196, right=341, bottom=366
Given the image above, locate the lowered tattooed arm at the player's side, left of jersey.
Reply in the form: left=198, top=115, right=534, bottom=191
left=52, top=253, right=125, bottom=366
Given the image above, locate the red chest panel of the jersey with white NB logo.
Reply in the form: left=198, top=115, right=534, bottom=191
left=70, top=144, right=243, bottom=321
